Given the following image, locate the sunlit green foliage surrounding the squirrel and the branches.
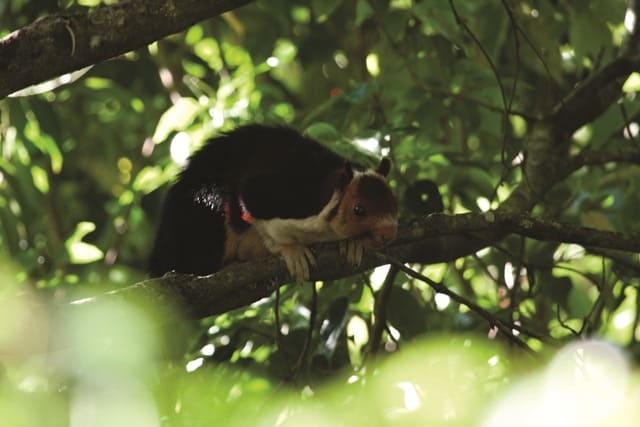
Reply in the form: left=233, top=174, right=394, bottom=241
left=0, top=0, right=640, bottom=426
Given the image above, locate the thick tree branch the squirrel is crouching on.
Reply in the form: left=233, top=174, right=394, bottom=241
left=66, top=212, right=640, bottom=319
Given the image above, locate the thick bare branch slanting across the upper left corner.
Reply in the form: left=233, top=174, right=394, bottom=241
left=0, top=0, right=251, bottom=99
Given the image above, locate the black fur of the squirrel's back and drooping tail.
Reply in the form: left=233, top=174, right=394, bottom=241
left=149, top=125, right=346, bottom=276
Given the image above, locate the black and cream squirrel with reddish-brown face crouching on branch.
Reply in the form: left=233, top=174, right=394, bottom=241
left=148, top=125, right=398, bottom=283
